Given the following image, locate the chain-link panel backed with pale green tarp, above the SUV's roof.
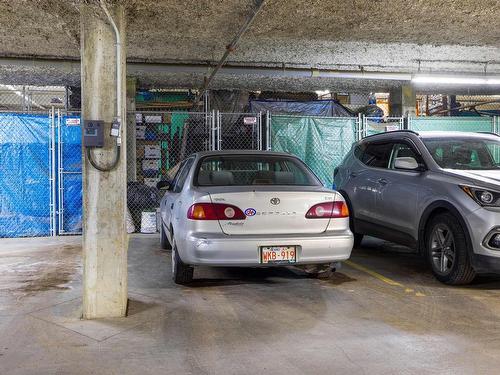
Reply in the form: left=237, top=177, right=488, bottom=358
left=408, top=116, right=495, bottom=132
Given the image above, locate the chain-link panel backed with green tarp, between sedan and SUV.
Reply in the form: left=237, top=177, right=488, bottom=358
left=268, top=116, right=357, bottom=187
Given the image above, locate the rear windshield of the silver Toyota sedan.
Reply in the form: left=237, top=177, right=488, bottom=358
left=195, top=155, right=320, bottom=186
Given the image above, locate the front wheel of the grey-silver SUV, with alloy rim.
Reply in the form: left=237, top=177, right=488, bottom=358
left=425, top=213, right=476, bottom=285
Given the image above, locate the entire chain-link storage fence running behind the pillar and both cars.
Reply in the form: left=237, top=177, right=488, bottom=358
left=0, top=103, right=500, bottom=237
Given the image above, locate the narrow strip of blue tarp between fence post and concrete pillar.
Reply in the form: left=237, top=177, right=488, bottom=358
left=58, top=116, right=82, bottom=233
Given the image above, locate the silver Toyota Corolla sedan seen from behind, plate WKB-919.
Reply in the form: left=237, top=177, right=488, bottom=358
left=159, top=151, right=353, bottom=284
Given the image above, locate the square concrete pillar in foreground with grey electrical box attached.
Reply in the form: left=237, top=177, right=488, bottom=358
left=80, top=3, right=128, bottom=319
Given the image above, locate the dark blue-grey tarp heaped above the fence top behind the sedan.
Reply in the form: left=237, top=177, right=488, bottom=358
left=250, top=100, right=353, bottom=117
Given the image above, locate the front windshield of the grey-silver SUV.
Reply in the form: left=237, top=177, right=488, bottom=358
left=423, top=137, right=500, bottom=170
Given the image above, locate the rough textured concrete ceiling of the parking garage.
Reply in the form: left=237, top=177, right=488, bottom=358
left=0, top=0, right=500, bottom=92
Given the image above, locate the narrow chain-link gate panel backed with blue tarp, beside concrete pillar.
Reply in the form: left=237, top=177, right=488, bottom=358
left=57, top=113, right=83, bottom=235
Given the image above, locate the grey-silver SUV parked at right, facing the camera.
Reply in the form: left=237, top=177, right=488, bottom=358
left=334, top=131, right=500, bottom=284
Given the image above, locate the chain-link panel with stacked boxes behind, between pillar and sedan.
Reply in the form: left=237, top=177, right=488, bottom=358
left=127, top=111, right=216, bottom=233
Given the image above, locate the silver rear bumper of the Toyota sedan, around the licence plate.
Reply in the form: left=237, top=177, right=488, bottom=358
left=177, top=230, right=353, bottom=267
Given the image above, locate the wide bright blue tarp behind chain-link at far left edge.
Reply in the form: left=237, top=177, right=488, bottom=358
left=0, top=113, right=50, bottom=237
